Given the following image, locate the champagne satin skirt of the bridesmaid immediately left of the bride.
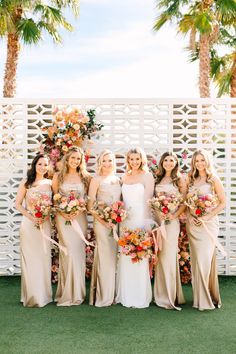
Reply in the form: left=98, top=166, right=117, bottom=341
left=89, top=220, right=117, bottom=307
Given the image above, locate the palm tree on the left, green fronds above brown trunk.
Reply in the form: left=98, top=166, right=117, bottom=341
left=0, top=0, right=79, bottom=97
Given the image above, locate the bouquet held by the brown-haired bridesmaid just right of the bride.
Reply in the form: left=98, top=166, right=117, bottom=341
left=149, top=192, right=183, bottom=224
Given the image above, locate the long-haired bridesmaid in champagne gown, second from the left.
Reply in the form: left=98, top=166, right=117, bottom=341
left=52, top=147, right=90, bottom=306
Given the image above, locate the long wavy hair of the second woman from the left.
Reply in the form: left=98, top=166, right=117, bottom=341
left=58, top=146, right=91, bottom=189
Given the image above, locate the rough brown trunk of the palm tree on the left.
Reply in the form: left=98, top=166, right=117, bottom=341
left=3, top=33, right=20, bottom=97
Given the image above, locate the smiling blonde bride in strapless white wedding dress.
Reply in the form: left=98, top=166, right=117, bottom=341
left=116, top=148, right=154, bottom=308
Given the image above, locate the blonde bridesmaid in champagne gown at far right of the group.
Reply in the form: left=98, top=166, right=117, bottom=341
left=187, top=150, right=225, bottom=311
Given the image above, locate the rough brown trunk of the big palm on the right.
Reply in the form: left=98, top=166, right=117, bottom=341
left=199, top=34, right=210, bottom=98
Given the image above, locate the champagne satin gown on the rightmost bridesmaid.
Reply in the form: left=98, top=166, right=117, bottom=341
left=186, top=183, right=221, bottom=310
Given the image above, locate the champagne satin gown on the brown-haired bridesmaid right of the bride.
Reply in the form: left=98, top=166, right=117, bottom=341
left=154, top=183, right=185, bottom=310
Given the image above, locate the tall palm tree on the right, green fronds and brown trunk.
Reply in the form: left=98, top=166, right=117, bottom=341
left=154, top=0, right=236, bottom=97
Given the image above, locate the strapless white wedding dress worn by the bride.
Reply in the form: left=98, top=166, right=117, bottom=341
left=116, top=183, right=152, bottom=308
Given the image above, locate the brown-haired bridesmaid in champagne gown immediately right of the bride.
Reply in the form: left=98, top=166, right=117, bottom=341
left=154, top=152, right=186, bottom=310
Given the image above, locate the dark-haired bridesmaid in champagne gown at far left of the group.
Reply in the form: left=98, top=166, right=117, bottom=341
left=16, top=154, right=52, bottom=307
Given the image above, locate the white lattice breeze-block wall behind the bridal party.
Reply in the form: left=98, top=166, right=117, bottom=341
left=0, top=99, right=236, bottom=275
